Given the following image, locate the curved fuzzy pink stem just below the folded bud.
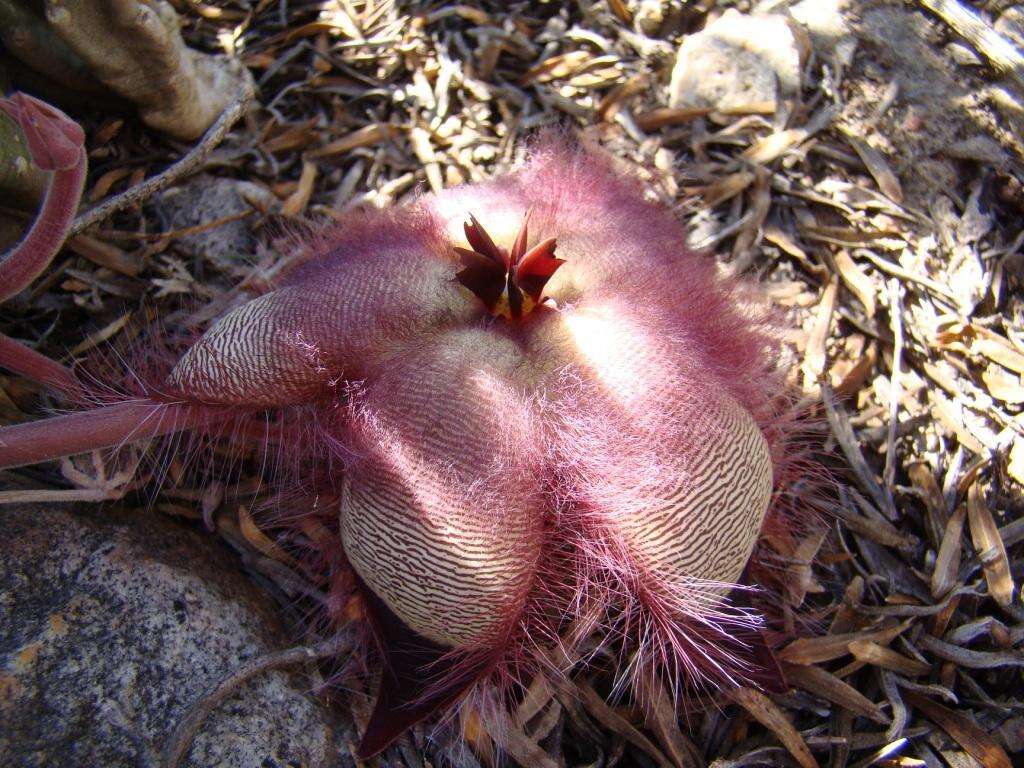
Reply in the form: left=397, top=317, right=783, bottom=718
left=0, top=147, right=86, bottom=302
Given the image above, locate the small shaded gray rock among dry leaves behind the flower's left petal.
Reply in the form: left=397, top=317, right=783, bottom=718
left=153, top=175, right=276, bottom=269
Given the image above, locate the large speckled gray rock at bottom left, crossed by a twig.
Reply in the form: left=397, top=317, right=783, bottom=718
left=0, top=506, right=353, bottom=768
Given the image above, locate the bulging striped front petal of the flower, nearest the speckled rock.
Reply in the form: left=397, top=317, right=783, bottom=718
left=341, top=330, right=545, bottom=647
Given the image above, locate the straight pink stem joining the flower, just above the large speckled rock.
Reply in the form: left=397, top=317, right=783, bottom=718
left=0, top=400, right=230, bottom=469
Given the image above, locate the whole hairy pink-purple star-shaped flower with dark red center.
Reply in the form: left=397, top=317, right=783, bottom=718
left=155, top=138, right=788, bottom=755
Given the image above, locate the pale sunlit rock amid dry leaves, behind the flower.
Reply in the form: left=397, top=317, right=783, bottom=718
left=669, top=8, right=807, bottom=112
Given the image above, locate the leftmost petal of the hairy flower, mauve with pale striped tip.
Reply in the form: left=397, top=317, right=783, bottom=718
left=169, top=207, right=483, bottom=407
